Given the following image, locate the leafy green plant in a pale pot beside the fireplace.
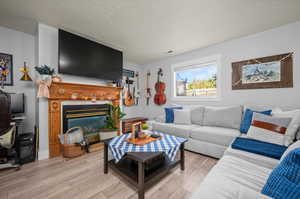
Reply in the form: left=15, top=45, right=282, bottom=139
left=99, top=104, right=126, bottom=140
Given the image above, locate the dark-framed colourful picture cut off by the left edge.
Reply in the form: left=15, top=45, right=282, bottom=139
left=0, top=53, right=13, bottom=88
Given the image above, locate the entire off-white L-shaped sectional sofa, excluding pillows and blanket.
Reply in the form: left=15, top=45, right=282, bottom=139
left=148, top=106, right=300, bottom=199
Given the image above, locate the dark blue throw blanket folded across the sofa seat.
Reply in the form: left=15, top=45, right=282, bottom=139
left=231, top=137, right=287, bottom=160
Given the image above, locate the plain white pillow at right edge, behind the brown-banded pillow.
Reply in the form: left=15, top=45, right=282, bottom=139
left=272, top=109, right=300, bottom=146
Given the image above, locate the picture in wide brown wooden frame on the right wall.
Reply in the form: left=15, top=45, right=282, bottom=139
left=232, top=53, right=293, bottom=90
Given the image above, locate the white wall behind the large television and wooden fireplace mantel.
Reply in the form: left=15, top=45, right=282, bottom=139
left=36, top=24, right=139, bottom=159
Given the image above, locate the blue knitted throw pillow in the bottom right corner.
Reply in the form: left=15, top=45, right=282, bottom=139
left=261, top=148, right=300, bottom=199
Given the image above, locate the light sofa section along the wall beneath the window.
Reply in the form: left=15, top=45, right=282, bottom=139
left=148, top=106, right=243, bottom=158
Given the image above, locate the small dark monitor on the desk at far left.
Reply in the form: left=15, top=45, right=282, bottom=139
left=9, top=93, right=25, bottom=114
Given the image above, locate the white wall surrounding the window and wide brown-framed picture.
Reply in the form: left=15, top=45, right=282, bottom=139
left=143, top=22, right=300, bottom=118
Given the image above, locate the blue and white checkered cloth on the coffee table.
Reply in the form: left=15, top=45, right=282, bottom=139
left=108, top=132, right=186, bottom=163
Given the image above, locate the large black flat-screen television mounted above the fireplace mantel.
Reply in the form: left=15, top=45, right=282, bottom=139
left=58, top=30, right=123, bottom=81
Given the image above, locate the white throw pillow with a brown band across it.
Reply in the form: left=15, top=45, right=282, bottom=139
left=247, top=113, right=291, bottom=145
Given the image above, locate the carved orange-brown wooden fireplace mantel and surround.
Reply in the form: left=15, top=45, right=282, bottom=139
left=46, top=82, right=121, bottom=158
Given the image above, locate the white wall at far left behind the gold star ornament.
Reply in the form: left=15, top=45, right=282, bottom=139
left=0, top=27, right=36, bottom=132
